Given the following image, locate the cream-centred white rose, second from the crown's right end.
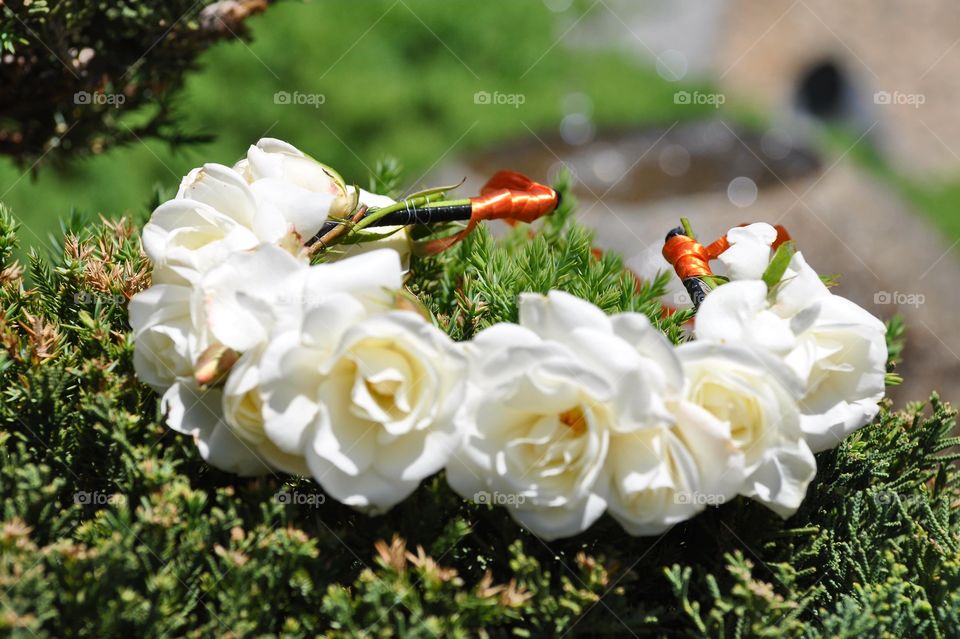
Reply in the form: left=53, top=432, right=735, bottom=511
left=677, top=342, right=817, bottom=517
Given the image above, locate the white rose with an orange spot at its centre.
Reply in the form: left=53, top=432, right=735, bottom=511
left=447, top=324, right=616, bottom=539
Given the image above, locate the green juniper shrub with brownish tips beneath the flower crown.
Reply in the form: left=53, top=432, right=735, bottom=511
left=0, top=186, right=960, bottom=638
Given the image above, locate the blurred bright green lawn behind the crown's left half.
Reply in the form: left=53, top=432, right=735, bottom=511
left=0, top=0, right=715, bottom=245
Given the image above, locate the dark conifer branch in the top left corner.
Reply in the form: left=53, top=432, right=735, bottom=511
left=0, top=0, right=269, bottom=168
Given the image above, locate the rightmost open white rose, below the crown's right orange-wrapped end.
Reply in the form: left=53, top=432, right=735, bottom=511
left=696, top=253, right=887, bottom=452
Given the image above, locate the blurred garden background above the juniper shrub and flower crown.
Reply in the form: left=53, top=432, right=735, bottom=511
left=0, top=0, right=960, bottom=401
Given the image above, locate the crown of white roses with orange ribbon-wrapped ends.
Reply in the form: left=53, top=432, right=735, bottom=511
left=129, top=139, right=887, bottom=539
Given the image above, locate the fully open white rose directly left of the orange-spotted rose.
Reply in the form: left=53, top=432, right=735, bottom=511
left=260, top=302, right=466, bottom=512
